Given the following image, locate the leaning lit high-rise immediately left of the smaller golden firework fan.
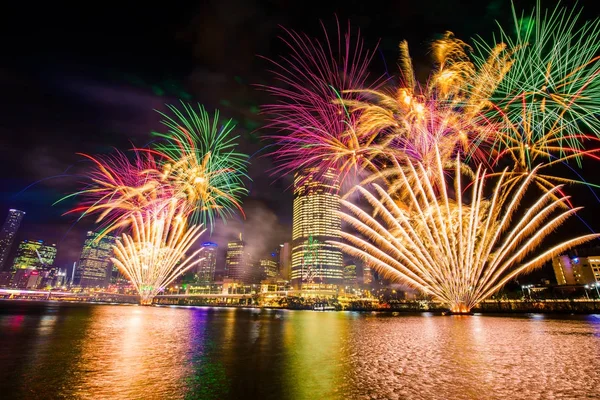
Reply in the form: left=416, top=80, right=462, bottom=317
left=73, top=231, right=116, bottom=287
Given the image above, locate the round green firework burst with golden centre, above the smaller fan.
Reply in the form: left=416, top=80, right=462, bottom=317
left=149, top=103, right=249, bottom=229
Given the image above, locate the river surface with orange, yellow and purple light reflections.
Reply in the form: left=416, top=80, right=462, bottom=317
left=0, top=302, right=600, bottom=400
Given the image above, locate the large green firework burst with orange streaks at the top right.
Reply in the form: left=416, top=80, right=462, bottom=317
left=475, top=2, right=600, bottom=180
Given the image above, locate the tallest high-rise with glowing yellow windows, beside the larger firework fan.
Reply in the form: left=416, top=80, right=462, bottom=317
left=291, top=168, right=344, bottom=287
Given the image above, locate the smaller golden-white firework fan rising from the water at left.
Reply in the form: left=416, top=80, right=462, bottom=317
left=112, top=201, right=204, bottom=305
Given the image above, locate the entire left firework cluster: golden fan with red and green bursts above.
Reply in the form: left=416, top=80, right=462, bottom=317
left=67, top=104, right=248, bottom=304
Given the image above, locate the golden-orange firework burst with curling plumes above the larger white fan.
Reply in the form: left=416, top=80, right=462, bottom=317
left=342, top=32, right=510, bottom=189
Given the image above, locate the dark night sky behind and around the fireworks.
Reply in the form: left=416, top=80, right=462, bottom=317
left=0, top=0, right=598, bottom=278
